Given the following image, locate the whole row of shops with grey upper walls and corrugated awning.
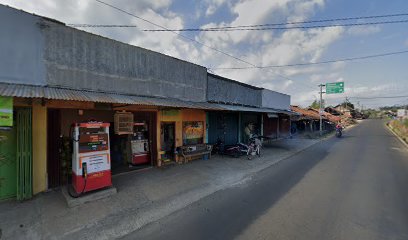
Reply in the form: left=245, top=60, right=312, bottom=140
left=0, top=6, right=294, bottom=199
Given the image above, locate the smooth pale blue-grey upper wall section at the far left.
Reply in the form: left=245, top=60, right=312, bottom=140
left=0, top=5, right=46, bottom=85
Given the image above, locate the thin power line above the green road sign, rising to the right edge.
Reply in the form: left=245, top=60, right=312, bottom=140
left=212, top=50, right=408, bottom=70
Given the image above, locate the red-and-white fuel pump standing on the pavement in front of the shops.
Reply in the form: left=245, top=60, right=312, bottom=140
left=72, top=122, right=112, bottom=194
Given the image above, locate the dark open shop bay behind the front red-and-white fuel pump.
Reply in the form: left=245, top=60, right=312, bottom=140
left=46, top=100, right=158, bottom=188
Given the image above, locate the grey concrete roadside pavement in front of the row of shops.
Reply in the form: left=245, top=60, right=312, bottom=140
left=0, top=139, right=320, bottom=239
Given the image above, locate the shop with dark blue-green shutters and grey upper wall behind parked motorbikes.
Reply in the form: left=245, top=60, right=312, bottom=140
left=207, top=74, right=293, bottom=144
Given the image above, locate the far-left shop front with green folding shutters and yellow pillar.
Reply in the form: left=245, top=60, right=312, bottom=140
left=0, top=96, right=46, bottom=200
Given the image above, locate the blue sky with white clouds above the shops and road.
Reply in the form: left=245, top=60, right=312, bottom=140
left=0, top=0, right=408, bottom=107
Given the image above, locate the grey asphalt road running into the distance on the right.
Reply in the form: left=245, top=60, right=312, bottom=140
left=125, top=120, right=408, bottom=240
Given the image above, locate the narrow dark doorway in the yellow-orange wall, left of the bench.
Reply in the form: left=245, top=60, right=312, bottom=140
left=160, top=122, right=176, bottom=163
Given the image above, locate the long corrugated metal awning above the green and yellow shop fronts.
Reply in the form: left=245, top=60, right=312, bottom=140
left=0, top=83, right=224, bottom=110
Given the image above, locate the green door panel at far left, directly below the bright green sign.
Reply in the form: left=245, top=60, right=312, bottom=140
left=0, top=124, right=17, bottom=200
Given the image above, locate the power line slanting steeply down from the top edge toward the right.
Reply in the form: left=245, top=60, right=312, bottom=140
left=95, top=0, right=311, bottom=91
